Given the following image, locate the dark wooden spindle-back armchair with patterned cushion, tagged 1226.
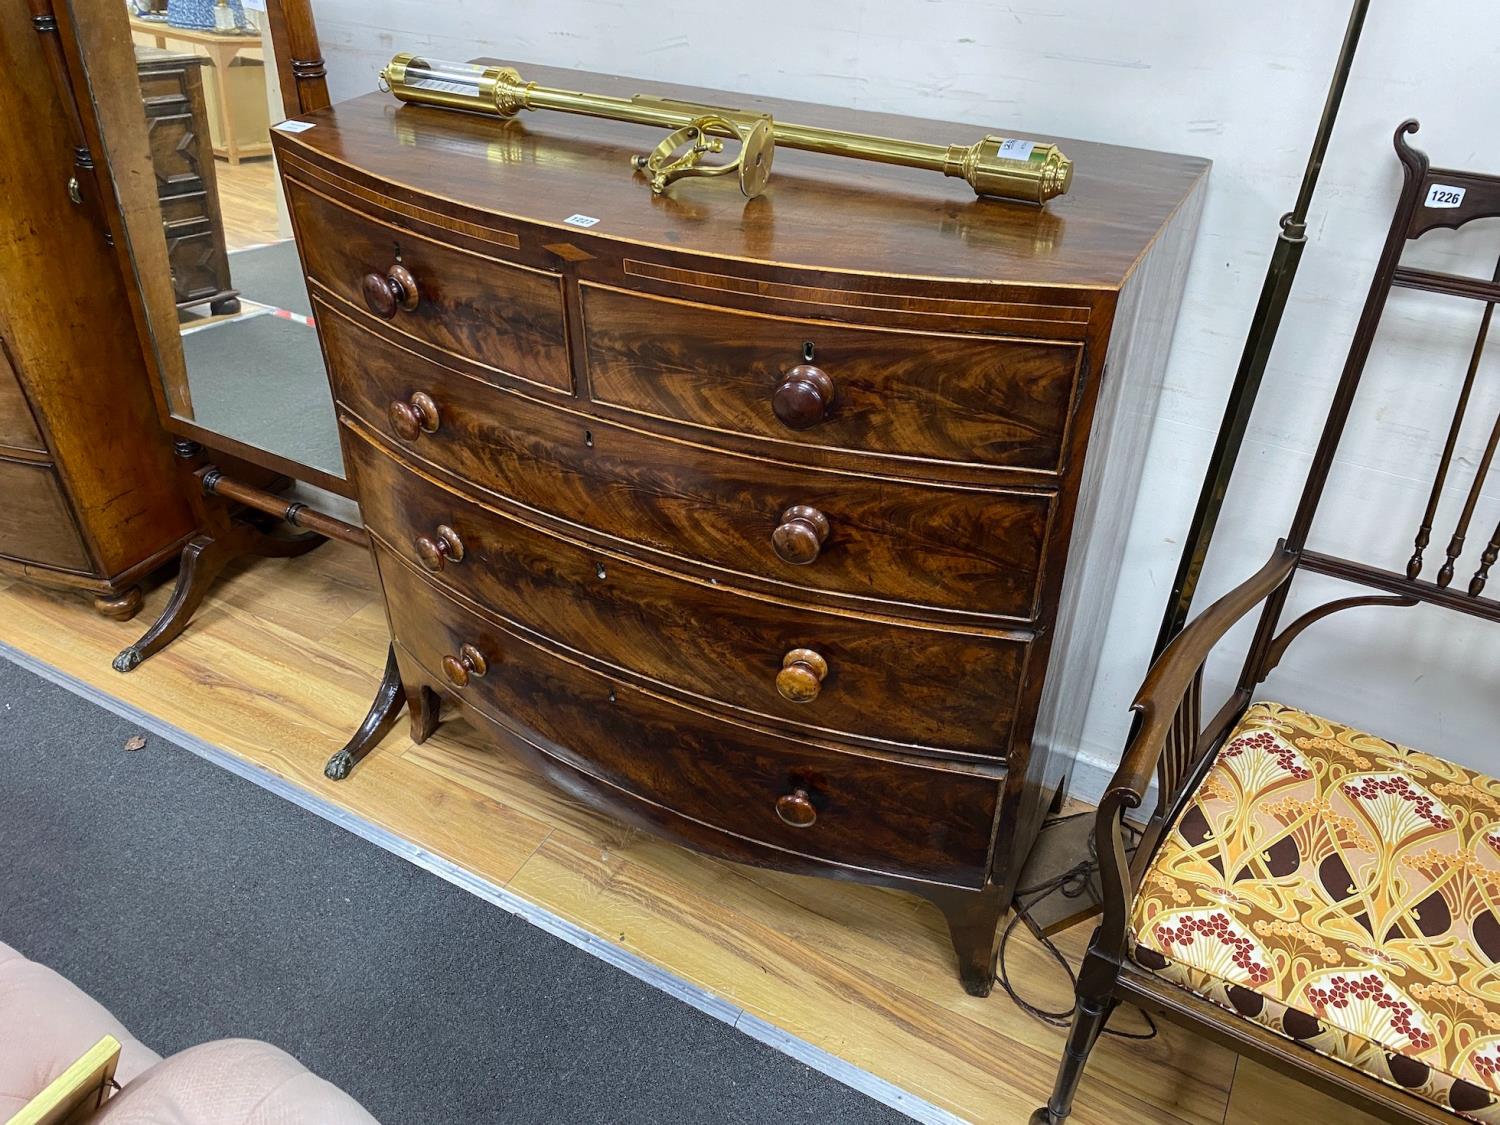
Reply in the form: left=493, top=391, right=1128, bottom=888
left=1032, top=122, right=1500, bottom=1125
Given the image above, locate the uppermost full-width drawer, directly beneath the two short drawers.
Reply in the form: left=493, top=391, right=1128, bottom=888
left=315, top=302, right=1055, bottom=621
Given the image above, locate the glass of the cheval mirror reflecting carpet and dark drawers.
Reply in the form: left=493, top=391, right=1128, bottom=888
left=109, top=0, right=344, bottom=477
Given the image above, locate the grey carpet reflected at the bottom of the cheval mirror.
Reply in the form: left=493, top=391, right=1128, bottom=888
left=183, top=314, right=344, bottom=477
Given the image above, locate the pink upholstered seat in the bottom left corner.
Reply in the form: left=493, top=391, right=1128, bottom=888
left=0, top=944, right=378, bottom=1125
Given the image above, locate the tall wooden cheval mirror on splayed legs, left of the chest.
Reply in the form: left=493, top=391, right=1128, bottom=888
left=46, top=0, right=366, bottom=672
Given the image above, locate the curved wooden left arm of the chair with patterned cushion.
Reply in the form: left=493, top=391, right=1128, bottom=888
left=1094, top=546, right=1298, bottom=957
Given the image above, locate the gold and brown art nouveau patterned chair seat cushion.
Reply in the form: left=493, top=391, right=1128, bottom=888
left=1131, top=704, right=1500, bottom=1124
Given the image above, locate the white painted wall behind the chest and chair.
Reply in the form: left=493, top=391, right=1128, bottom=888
left=304, top=0, right=1500, bottom=798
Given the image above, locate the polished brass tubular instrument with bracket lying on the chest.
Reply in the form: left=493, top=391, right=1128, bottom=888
left=380, top=54, right=1073, bottom=204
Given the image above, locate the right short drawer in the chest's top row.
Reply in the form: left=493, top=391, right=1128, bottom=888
left=582, top=285, right=1082, bottom=473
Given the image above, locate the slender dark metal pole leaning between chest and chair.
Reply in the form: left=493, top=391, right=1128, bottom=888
left=1151, top=0, right=1370, bottom=660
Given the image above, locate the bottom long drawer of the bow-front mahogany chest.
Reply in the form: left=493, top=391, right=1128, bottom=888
left=378, top=552, right=1001, bottom=887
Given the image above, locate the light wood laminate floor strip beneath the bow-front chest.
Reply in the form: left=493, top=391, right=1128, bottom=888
left=0, top=555, right=1374, bottom=1125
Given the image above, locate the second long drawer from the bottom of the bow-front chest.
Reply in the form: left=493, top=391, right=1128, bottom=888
left=347, top=426, right=1029, bottom=758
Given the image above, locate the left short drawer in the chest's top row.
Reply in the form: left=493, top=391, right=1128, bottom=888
left=287, top=180, right=573, bottom=393
